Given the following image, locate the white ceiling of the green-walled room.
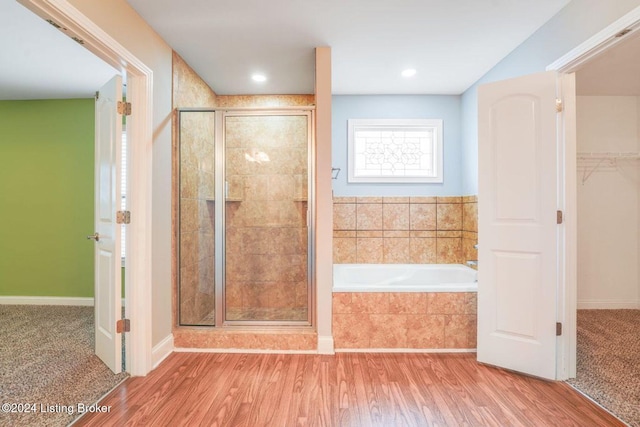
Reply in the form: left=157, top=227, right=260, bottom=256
left=0, top=0, right=116, bottom=100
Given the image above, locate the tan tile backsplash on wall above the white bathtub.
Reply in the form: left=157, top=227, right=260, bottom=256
left=333, top=196, right=478, bottom=264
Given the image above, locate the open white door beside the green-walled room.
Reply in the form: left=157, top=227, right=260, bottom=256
left=94, top=76, right=122, bottom=373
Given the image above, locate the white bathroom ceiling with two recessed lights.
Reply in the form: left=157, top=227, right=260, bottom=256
left=128, top=0, right=569, bottom=94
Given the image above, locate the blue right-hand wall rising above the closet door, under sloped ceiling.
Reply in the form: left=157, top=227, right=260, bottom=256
left=461, top=0, right=640, bottom=194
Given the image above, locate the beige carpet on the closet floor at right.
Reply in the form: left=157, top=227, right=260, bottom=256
left=568, top=310, right=640, bottom=427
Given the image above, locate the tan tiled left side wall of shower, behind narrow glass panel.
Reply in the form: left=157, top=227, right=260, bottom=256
left=173, top=52, right=216, bottom=325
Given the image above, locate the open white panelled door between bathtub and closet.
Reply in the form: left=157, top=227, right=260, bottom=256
left=477, top=72, right=559, bottom=379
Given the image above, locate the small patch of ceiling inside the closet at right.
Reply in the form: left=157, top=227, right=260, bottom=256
left=576, top=33, right=640, bottom=96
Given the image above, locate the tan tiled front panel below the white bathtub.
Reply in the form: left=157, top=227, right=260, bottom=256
left=333, top=292, right=477, bottom=350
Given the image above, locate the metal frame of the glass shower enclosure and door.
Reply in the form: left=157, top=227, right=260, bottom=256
left=176, top=106, right=316, bottom=329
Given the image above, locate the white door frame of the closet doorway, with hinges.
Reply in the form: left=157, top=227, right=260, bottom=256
left=546, top=6, right=640, bottom=380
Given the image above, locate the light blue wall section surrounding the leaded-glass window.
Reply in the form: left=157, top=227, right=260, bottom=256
left=331, top=95, right=463, bottom=196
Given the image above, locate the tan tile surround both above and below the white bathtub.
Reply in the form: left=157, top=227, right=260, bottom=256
left=333, top=196, right=478, bottom=350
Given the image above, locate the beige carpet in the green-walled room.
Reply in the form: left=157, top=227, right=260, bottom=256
left=0, top=305, right=127, bottom=426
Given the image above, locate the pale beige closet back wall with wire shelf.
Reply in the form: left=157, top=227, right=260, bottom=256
left=577, top=96, right=640, bottom=309
